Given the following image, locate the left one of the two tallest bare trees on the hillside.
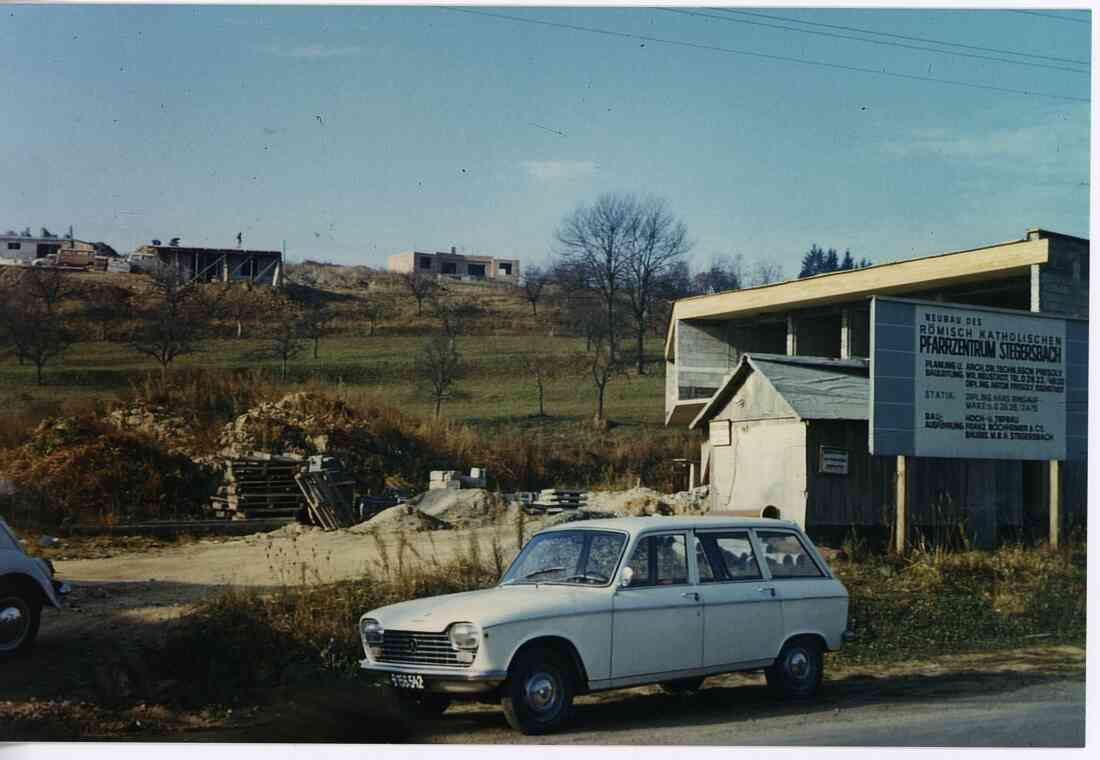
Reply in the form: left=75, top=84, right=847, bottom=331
left=554, top=194, right=641, bottom=354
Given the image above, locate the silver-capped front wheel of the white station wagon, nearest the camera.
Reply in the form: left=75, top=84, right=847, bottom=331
left=501, top=649, right=576, bottom=736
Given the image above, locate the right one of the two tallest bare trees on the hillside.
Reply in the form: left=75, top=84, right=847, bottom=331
left=623, top=198, right=691, bottom=375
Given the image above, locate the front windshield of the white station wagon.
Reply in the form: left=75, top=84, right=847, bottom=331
left=501, top=530, right=626, bottom=586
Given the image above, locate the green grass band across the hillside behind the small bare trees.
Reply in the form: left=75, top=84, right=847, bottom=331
left=0, top=335, right=664, bottom=432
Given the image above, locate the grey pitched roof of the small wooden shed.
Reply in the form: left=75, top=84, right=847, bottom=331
left=690, top=353, right=871, bottom=428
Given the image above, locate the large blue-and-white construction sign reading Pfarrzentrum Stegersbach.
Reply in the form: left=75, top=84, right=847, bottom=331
left=870, top=297, right=1088, bottom=460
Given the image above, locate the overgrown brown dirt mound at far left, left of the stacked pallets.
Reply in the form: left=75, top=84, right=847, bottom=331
left=0, top=417, right=213, bottom=526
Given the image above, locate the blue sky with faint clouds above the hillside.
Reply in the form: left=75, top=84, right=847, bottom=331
left=0, top=5, right=1090, bottom=275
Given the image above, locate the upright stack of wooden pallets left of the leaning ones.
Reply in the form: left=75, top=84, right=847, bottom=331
left=210, top=453, right=306, bottom=520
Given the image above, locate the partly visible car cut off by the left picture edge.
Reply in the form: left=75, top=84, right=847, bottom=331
left=0, top=518, right=68, bottom=660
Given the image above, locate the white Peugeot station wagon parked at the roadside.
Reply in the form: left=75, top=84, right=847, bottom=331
left=360, top=517, right=850, bottom=734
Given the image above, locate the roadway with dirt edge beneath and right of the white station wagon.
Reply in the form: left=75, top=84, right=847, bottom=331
left=419, top=650, right=1085, bottom=747
